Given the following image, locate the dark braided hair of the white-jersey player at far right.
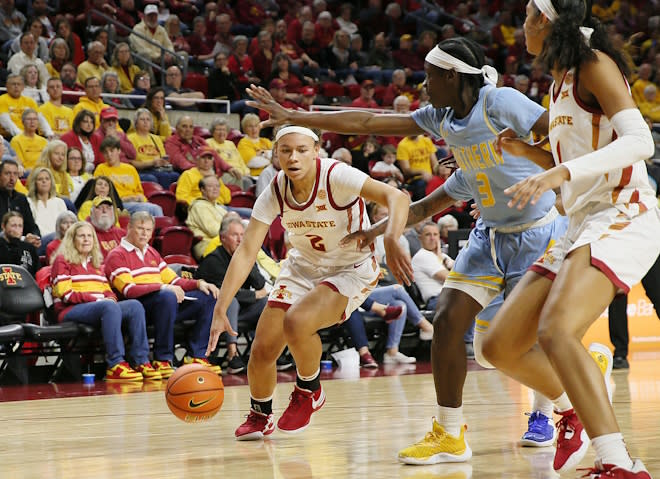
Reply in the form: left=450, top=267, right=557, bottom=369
left=532, top=0, right=630, bottom=75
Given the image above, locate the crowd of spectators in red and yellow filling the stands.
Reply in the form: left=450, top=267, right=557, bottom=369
left=0, top=0, right=660, bottom=380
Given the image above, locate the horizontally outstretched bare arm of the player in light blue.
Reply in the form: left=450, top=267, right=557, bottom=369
left=247, top=85, right=424, bottom=136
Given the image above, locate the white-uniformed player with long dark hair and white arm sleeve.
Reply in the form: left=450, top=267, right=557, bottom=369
left=483, top=0, right=660, bottom=479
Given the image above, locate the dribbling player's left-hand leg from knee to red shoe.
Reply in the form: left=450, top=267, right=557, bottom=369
left=234, top=306, right=286, bottom=441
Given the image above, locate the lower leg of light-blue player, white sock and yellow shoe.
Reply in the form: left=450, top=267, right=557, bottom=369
left=398, top=287, right=482, bottom=465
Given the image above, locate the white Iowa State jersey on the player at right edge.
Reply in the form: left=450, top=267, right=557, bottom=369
left=549, top=69, right=657, bottom=216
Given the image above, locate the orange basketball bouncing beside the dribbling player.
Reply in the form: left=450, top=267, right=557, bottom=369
left=165, top=364, right=225, bottom=422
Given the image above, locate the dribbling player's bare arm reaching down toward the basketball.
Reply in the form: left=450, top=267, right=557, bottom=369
left=206, top=218, right=269, bottom=356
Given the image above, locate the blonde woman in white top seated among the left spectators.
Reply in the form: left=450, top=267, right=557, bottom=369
left=27, top=166, right=67, bottom=237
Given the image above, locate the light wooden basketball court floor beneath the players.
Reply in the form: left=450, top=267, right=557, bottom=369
left=0, top=356, right=660, bottom=479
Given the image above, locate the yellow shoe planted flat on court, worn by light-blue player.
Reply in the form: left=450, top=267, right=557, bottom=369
left=399, top=417, right=472, bottom=465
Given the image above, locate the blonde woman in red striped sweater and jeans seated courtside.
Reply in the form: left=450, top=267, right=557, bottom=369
left=51, top=221, right=161, bottom=382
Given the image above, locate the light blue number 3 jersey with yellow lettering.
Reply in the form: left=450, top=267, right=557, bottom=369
left=412, top=85, right=555, bottom=227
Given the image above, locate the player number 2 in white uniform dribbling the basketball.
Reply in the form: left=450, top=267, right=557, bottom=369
left=207, top=126, right=412, bottom=440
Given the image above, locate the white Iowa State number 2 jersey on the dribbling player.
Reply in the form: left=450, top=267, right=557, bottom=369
left=252, top=158, right=372, bottom=266
